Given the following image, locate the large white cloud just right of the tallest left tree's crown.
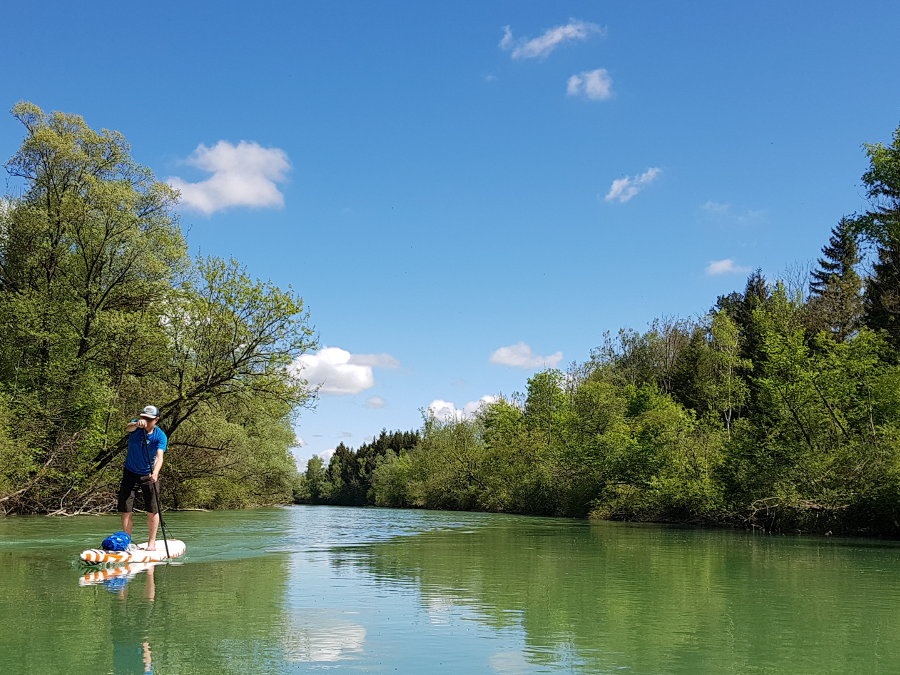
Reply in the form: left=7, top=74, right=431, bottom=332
left=167, top=141, right=291, bottom=215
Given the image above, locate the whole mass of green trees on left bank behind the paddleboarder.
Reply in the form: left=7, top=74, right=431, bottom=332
left=0, top=103, right=315, bottom=514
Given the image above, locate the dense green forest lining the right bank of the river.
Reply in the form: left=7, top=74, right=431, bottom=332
left=298, top=120, right=900, bottom=537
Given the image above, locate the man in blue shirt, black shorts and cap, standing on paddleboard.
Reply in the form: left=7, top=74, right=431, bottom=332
left=119, top=405, right=169, bottom=551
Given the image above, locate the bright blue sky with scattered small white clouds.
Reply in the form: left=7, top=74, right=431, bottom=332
left=0, top=0, right=900, bottom=462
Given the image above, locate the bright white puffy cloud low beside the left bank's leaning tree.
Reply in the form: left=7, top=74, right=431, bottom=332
left=294, top=347, right=400, bottom=396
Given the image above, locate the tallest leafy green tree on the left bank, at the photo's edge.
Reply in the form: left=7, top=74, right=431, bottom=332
left=0, top=103, right=185, bottom=510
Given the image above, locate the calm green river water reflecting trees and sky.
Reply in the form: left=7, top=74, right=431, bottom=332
left=0, top=507, right=900, bottom=675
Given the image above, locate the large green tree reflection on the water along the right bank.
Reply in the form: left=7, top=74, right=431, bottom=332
left=333, top=519, right=900, bottom=672
